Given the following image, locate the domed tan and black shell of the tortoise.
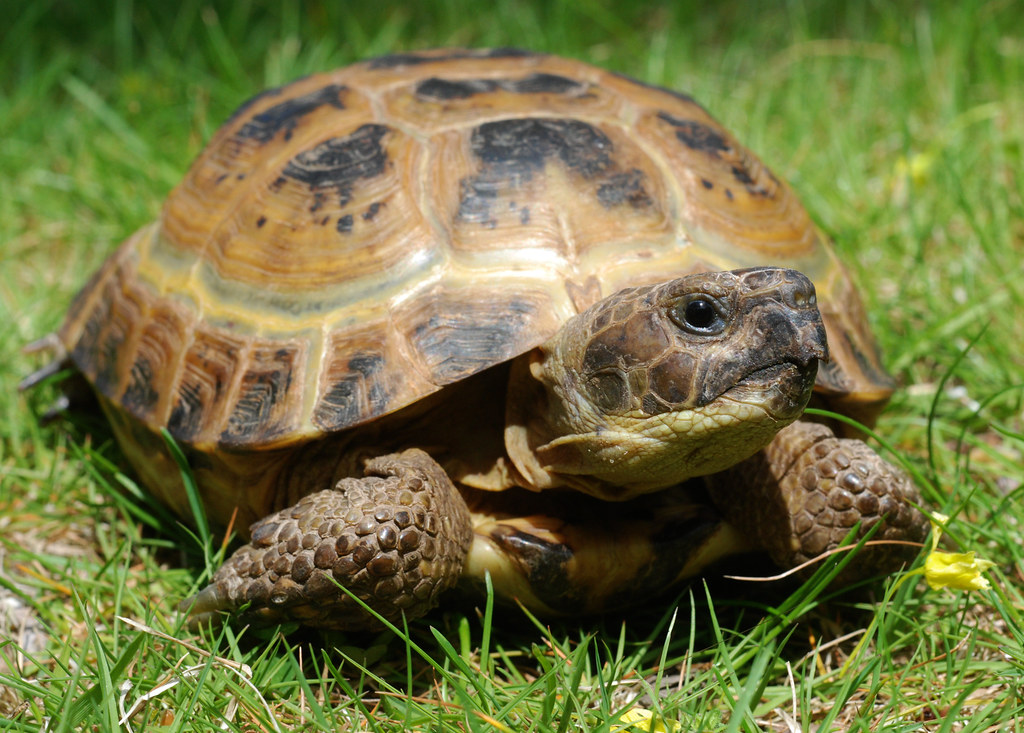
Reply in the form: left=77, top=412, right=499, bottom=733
left=60, top=49, right=891, bottom=450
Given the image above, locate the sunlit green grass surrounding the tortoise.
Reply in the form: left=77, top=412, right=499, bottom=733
left=0, top=0, right=1024, bottom=732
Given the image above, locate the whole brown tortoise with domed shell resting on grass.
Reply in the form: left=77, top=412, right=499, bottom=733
left=32, top=48, right=927, bottom=630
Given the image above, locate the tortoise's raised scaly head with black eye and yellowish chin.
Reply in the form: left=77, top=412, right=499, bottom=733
left=506, top=267, right=827, bottom=500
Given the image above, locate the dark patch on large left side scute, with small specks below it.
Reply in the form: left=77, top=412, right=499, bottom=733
left=282, top=124, right=389, bottom=208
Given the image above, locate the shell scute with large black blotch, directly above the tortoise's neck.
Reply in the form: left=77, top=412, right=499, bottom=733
left=428, top=118, right=679, bottom=274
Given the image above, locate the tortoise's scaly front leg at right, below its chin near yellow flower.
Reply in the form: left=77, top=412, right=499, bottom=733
left=708, top=421, right=929, bottom=579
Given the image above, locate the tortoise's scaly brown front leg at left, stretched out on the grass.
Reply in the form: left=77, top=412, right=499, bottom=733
left=181, top=449, right=473, bottom=630
